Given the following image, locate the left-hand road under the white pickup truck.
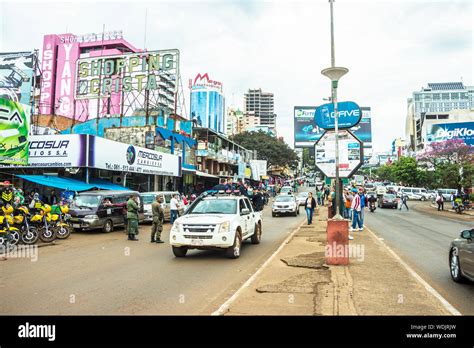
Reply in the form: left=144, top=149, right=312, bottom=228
left=0, top=206, right=304, bottom=315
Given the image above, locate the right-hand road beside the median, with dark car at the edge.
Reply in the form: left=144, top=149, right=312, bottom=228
left=364, top=201, right=474, bottom=315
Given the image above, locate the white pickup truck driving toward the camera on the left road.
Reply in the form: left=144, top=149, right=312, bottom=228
left=170, top=193, right=262, bottom=259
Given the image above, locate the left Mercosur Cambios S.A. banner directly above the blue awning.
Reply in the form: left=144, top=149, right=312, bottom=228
left=0, top=134, right=87, bottom=168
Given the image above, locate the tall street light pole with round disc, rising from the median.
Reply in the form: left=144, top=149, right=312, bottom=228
left=321, top=0, right=349, bottom=220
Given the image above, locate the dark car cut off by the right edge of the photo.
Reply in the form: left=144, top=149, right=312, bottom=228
left=449, top=228, right=474, bottom=282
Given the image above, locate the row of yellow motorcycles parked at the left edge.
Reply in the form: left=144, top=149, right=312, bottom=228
left=0, top=204, right=73, bottom=247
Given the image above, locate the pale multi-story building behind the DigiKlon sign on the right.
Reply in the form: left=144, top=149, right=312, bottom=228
left=405, top=82, right=474, bottom=154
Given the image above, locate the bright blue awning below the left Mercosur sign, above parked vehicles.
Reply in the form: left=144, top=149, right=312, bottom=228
left=17, top=175, right=130, bottom=192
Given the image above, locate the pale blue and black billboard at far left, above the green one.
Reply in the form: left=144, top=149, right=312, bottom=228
left=0, top=52, right=35, bottom=105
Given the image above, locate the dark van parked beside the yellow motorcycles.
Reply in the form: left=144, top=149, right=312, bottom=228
left=69, top=190, right=145, bottom=232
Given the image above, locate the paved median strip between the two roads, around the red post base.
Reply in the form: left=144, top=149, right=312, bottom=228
left=219, top=207, right=452, bottom=315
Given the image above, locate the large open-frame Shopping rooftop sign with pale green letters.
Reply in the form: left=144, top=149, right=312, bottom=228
left=75, top=49, right=179, bottom=99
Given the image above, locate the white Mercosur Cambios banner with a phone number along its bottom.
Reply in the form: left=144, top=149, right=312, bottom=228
left=89, top=136, right=181, bottom=176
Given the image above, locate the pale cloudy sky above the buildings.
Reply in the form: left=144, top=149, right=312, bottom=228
left=0, top=0, right=474, bottom=151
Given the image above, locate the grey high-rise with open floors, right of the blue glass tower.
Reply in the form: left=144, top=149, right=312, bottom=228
left=244, top=89, right=276, bottom=133
